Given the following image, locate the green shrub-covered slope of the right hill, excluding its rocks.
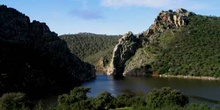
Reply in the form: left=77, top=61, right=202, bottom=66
left=149, top=16, right=220, bottom=77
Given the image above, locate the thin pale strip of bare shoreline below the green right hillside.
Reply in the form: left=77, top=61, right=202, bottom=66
left=158, top=74, right=220, bottom=80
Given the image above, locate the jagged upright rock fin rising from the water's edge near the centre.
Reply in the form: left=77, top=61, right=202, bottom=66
left=107, top=32, right=141, bottom=77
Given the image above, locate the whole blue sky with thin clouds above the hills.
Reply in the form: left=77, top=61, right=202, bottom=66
left=0, top=0, right=220, bottom=35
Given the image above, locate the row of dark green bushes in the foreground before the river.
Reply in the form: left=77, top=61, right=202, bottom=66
left=0, top=87, right=220, bottom=110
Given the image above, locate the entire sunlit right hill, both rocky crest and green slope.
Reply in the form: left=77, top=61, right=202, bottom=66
left=109, top=9, right=220, bottom=77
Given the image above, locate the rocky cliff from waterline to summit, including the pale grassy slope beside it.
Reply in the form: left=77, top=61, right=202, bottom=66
left=107, top=8, right=195, bottom=76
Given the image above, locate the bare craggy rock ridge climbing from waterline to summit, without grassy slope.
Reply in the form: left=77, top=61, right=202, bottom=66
left=108, top=8, right=195, bottom=76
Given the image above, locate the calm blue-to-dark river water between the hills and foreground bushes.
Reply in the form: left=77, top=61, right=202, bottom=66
left=82, top=75, right=220, bottom=105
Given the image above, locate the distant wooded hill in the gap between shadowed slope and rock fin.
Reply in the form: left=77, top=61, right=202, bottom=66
left=59, top=33, right=121, bottom=68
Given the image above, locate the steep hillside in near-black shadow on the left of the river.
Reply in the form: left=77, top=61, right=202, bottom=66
left=0, top=5, right=95, bottom=93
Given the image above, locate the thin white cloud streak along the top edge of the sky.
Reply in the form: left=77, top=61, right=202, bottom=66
left=101, top=0, right=208, bottom=10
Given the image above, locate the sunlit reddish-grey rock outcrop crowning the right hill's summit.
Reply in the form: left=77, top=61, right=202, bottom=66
left=144, top=8, right=195, bottom=43
